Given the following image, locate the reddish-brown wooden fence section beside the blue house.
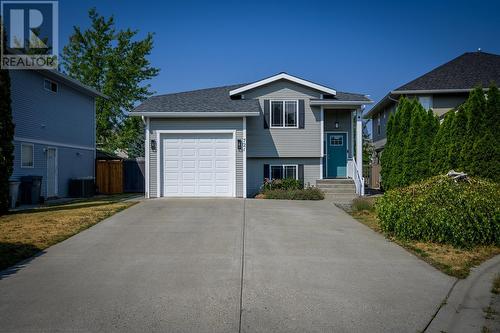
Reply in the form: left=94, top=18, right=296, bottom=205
left=96, top=161, right=123, bottom=194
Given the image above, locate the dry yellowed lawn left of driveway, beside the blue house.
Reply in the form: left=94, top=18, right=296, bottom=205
left=0, top=195, right=135, bottom=270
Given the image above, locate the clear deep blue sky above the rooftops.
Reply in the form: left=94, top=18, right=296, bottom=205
left=59, top=0, right=500, bottom=111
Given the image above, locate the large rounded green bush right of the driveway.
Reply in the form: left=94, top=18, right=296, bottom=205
left=376, top=176, right=500, bottom=248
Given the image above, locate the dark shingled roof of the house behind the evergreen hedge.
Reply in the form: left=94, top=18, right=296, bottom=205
left=394, top=51, right=500, bottom=91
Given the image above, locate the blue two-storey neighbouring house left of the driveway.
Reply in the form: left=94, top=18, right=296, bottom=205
left=10, top=70, right=105, bottom=198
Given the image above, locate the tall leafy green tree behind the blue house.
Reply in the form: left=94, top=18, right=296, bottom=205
left=62, top=8, right=159, bottom=153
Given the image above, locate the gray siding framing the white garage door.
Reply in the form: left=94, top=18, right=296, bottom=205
left=149, top=118, right=243, bottom=198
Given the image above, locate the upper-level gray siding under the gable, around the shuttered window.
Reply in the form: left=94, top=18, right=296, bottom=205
left=244, top=80, right=321, bottom=158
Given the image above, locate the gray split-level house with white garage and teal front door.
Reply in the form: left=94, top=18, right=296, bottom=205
left=132, top=73, right=371, bottom=197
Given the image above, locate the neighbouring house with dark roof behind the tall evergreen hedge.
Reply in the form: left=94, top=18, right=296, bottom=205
left=365, top=51, right=500, bottom=188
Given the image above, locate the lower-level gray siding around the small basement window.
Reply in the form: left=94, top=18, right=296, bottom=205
left=247, top=158, right=320, bottom=197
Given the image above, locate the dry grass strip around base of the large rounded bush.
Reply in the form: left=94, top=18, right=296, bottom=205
left=350, top=198, right=500, bottom=279
